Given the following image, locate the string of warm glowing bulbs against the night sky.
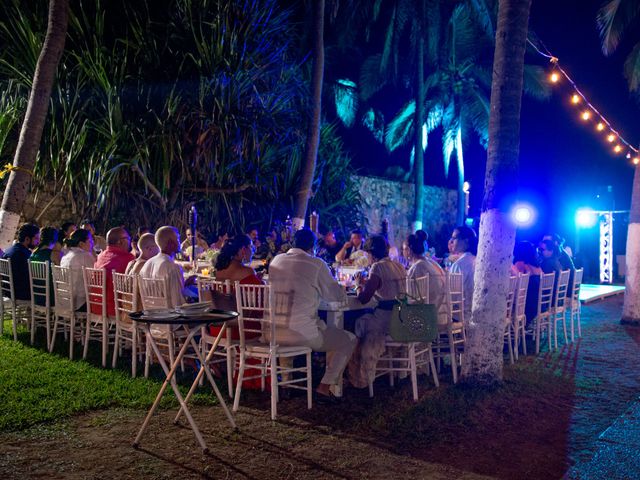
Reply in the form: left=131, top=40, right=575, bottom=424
left=527, top=38, right=640, bottom=161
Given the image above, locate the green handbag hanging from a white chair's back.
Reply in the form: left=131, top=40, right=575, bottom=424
left=389, top=295, right=438, bottom=343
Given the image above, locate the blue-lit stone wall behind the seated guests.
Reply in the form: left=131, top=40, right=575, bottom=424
left=355, top=176, right=458, bottom=254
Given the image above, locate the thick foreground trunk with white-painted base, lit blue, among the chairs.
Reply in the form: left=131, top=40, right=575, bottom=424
left=462, top=0, right=531, bottom=386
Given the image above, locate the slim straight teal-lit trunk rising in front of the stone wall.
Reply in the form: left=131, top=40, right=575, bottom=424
left=413, top=0, right=425, bottom=231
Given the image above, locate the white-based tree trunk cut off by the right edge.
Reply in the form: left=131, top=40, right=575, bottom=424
left=622, top=165, right=640, bottom=326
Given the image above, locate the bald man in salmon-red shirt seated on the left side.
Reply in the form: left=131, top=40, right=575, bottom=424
left=91, top=227, right=135, bottom=316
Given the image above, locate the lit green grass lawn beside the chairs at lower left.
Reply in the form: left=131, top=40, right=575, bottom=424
left=0, top=321, right=214, bottom=431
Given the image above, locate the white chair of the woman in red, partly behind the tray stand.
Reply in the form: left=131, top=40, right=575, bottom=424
left=196, top=277, right=239, bottom=398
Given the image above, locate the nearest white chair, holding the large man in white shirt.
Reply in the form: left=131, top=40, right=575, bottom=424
left=233, top=282, right=313, bottom=420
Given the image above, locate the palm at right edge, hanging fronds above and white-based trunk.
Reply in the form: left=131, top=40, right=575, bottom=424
left=598, top=0, right=640, bottom=325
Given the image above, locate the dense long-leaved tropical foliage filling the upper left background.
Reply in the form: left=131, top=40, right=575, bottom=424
left=0, top=0, right=354, bottom=235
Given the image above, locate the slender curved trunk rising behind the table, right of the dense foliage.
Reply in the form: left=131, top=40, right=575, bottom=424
left=293, top=0, right=324, bottom=230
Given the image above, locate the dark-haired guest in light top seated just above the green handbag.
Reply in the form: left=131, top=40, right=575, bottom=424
left=403, top=234, right=448, bottom=325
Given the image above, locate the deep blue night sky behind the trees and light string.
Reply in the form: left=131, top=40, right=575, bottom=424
left=342, top=0, right=640, bottom=251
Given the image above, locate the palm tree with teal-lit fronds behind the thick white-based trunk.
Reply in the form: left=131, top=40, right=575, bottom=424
left=385, top=0, right=550, bottom=224
